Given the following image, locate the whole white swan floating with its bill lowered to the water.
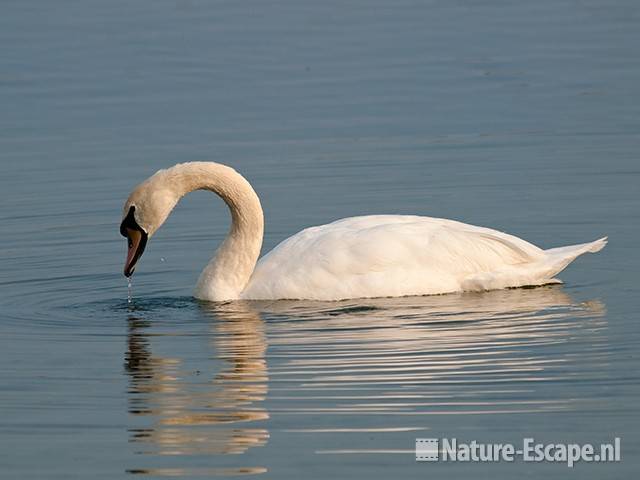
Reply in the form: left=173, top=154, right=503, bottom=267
left=120, top=162, right=607, bottom=301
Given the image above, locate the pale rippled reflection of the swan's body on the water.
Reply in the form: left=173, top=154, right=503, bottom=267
left=255, top=286, right=608, bottom=422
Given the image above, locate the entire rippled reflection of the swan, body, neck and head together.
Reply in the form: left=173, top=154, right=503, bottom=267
left=122, top=286, right=609, bottom=475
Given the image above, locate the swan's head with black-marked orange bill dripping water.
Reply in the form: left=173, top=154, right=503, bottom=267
left=120, top=170, right=180, bottom=277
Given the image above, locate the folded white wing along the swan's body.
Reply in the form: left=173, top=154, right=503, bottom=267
left=242, top=215, right=544, bottom=300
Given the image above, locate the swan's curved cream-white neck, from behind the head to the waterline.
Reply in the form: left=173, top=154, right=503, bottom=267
left=165, top=162, right=264, bottom=301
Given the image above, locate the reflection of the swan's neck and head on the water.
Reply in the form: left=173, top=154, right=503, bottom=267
left=126, top=302, right=269, bottom=476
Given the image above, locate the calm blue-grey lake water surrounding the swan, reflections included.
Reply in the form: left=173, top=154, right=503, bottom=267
left=0, top=0, right=640, bottom=479
